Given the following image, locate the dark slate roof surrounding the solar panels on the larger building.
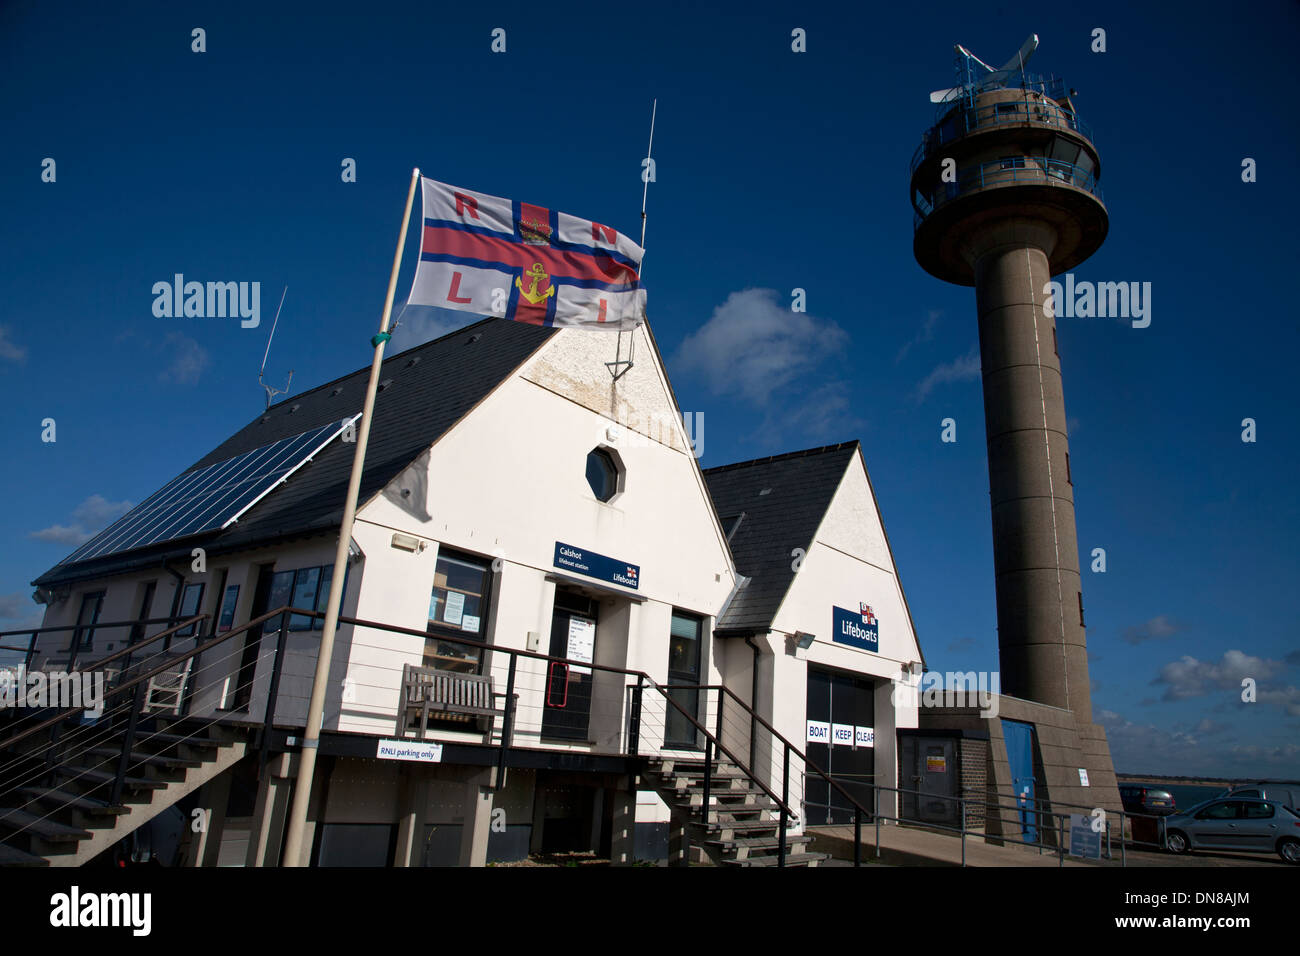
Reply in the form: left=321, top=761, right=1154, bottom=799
left=33, top=319, right=555, bottom=587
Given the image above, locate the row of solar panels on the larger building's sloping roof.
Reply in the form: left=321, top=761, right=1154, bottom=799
left=59, top=415, right=361, bottom=564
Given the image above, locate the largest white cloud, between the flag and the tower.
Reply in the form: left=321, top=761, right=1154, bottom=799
left=672, top=289, right=849, bottom=405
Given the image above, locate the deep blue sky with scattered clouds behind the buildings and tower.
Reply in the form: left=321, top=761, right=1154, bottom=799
left=0, top=1, right=1300, bottom=777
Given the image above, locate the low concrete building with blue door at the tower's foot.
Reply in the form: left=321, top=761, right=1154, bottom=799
left=915, top=695, right=1123, bottom=852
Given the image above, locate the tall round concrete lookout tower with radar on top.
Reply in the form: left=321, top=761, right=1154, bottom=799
left=910, top=35, right=1118, bottom=832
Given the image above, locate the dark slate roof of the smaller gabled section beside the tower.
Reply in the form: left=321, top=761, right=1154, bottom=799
left=703, top=441, right=858, bottom=632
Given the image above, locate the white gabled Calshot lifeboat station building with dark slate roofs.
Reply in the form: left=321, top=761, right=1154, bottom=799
left=10, top=319, right=923, bottom=866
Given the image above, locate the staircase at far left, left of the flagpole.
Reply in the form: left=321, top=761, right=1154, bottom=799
left=0, top=722, right=247, bottom=866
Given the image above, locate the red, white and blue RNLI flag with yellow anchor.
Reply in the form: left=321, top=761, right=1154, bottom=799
left=407, top=179, right=645, bottom=330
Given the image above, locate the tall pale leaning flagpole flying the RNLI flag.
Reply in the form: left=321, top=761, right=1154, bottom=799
left=280, top=168, right=420, bottom=866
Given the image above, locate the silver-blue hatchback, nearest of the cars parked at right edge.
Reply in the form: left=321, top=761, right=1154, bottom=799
left=1165, top=795, right=1300, bottom=864
